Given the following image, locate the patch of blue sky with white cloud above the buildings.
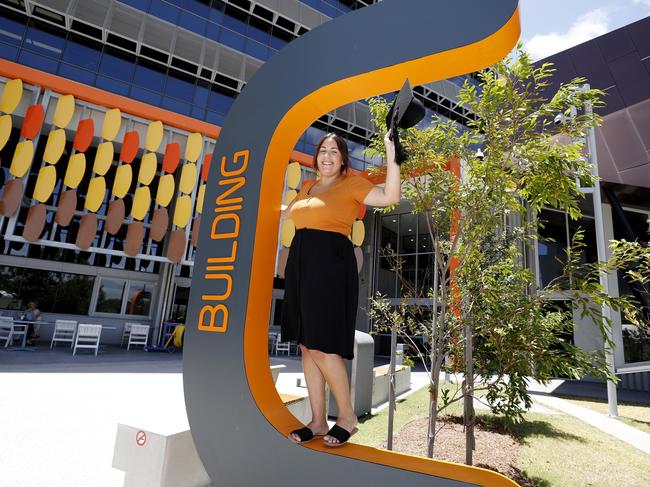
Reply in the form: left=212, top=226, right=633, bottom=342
left=520, top=0, right=650, bottom=60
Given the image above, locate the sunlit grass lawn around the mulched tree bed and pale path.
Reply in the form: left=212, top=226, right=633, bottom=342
left=354, top=388, right=650, bottom=487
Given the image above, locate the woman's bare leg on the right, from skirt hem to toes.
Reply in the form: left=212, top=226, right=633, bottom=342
left=309, top=350, right=358, bottom=443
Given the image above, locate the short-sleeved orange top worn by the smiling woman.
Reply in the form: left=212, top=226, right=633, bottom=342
left=289, top=176, right=375, bottom=237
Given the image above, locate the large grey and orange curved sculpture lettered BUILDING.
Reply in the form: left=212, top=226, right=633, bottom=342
left=183, top=0, right=520, bottom=487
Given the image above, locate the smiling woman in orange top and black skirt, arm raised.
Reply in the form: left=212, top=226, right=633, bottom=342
left=281, top=132, right=400, bottom=447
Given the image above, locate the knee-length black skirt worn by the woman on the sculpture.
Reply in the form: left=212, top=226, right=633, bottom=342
left=281, top=229, right=359, bottom=359
